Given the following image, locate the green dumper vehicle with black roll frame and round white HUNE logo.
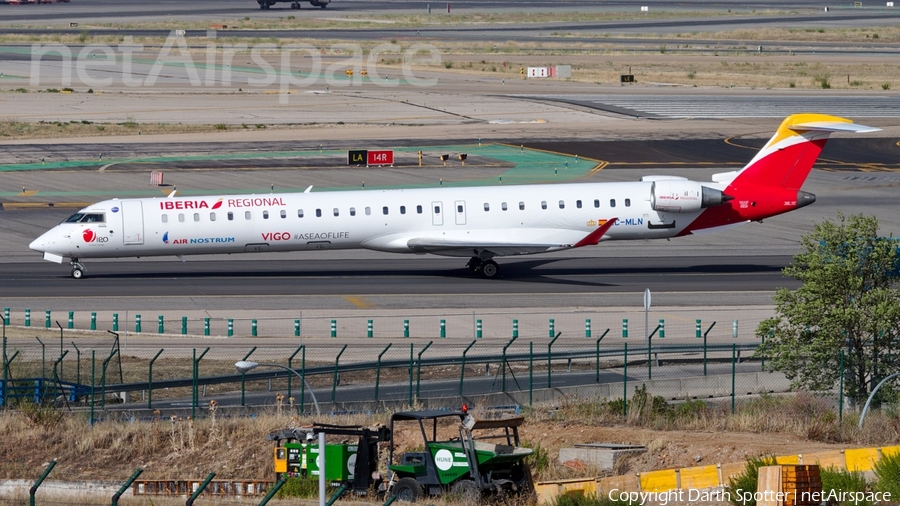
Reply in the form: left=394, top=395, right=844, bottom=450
left=388, top=410, right=533, bottom=503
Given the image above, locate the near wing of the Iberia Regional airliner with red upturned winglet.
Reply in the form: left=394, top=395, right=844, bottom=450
left=406, top=218, right=616, bottom=256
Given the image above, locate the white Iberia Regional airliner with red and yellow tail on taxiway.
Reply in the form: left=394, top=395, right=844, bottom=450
left=29, top=114, right=879, bottom=279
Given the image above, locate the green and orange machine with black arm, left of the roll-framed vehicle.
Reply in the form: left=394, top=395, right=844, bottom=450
left=266, top=423, right=391, bottom=495
